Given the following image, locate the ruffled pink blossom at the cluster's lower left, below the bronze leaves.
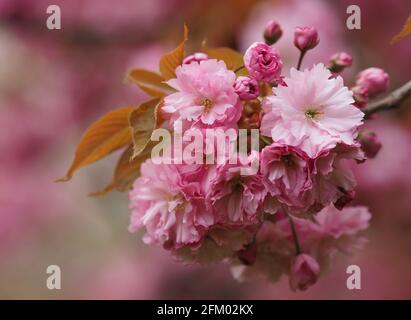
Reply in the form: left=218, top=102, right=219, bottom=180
left=129, top=160, right=214, bottom=248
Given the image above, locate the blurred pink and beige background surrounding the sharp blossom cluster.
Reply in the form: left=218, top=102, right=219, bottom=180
left=0, top=0, right=411, bottom=299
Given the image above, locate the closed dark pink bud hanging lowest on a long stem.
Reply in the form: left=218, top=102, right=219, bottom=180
left=290, top=253, right=320, bottom=291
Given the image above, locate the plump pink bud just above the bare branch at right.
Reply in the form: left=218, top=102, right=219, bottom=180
left=356, top=68, right=390, bottom=97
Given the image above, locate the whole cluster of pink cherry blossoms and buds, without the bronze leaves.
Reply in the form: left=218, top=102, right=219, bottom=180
left=129, top=21, right=389, bottom=290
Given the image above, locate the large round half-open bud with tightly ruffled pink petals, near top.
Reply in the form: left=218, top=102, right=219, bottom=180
left=244, top=42, right=283, bottom=82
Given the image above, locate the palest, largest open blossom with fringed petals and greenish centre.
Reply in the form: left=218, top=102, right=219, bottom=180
left=261, top=64, right=364, bottom=158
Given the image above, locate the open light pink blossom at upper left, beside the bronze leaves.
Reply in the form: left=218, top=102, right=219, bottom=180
left=162, top=59, right=242, bottom=127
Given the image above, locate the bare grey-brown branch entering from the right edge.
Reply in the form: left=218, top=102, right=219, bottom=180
left=362, top=80, right=411, bottom=118
